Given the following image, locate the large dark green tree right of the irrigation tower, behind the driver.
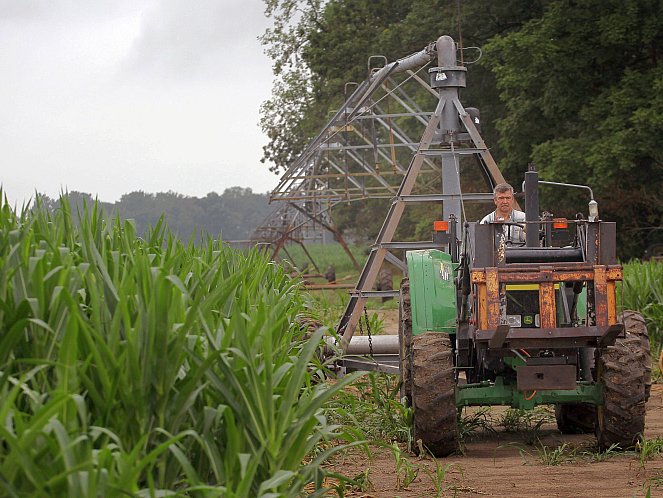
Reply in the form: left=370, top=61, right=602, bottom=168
left=484, top=0, right=663, bottom=258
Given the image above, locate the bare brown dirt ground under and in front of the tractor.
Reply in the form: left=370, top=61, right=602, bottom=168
left=333, top=312, right=663, bottom=498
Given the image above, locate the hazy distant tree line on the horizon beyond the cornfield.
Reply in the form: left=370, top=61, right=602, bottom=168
left=40, top=187, right=271, bottom=241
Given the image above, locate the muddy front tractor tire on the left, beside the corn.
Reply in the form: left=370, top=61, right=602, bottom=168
left=411, top=332, right=459, bottom=457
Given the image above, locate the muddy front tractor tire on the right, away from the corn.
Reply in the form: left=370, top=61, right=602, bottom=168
left=595, top=322, right=651, bottom=450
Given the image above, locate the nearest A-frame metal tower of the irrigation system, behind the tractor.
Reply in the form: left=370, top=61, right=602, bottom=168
left=337, top=36, right=504, bottom=346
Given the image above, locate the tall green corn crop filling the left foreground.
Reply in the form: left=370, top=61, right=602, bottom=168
left=0, top=196, right=354, bottom=498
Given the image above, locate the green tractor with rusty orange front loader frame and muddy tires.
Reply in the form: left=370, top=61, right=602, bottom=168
left=399, top=168, right=651, bottom=456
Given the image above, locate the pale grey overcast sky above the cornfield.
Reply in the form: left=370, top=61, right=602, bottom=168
left=0, top=0, right=278, bottom=204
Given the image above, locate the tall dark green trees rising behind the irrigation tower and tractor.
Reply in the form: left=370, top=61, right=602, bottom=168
left=261, top=0, right=663, bottom=259
